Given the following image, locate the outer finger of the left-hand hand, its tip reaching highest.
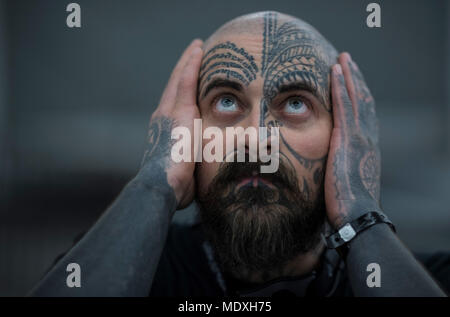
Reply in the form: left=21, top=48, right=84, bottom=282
left=160, top=39, right=203, bottom=107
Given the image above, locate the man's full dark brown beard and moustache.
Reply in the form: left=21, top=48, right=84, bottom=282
left=197, top=160, right=325, bottom=279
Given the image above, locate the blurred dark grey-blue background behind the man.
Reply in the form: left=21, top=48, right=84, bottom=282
left=0, top=0, right=450, bottom=296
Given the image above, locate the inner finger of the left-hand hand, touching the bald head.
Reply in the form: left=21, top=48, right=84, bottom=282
left=177, top=47, right=203, bottom=105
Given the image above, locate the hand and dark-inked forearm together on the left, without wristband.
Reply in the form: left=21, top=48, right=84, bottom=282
left=31, top=40, right=203, bottom=296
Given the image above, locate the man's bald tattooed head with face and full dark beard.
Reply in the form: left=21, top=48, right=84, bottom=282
left=196, top=12, right=337, bottom=281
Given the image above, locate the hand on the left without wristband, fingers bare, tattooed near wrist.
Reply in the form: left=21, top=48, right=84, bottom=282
left=140, top=40, right=203, bottom=208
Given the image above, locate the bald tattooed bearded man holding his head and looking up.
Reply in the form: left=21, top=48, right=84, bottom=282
left=30, top=12, right=445, bottom=296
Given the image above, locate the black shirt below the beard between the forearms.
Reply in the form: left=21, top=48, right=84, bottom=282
left=150, top=211, right=450, bottom=296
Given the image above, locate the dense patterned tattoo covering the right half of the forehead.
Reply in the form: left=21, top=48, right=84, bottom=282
left=261, top=12, right=329, bottom=110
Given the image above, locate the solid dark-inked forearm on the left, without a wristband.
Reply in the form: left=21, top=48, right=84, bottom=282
left=32, top=170, right=176, bottom=296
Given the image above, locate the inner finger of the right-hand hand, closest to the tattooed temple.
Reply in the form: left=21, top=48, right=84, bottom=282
left=331, top=64, right=355, bottom=132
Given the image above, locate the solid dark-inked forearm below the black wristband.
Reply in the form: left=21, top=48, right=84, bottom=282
left=347, top=224, right=445, bottom=296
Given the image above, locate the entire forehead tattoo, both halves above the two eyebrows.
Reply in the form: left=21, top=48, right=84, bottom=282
left=199, top=12, right=333, bottom=111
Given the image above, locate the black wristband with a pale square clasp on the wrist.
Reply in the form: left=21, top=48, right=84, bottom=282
left=325, top=211, right=395, bottom=258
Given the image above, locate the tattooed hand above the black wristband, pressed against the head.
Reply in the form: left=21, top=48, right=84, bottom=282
left=325, top=53, right=381, bottom=229
